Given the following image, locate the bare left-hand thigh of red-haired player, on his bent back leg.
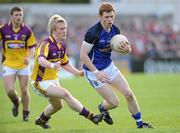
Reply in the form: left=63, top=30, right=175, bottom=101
left=96, top=84, right=119, bottom=104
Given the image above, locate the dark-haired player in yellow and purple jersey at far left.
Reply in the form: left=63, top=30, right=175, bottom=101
left=0, top=7, right=36, bottom=121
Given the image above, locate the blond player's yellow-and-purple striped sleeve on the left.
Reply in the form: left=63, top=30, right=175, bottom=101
left=37, top=43, right=49, bottom=59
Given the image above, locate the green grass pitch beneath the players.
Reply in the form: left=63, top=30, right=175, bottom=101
left=0, top=74, right=180, bottom=133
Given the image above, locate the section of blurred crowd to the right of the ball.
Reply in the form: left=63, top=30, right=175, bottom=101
left=117, top=17, right=180, bottom=58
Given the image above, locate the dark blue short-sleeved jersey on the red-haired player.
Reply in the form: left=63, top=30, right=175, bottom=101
left=83, top=22, right=120, bottom=70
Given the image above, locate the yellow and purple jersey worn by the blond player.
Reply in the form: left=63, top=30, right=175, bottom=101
left=31, top=36, right=69, bottom=82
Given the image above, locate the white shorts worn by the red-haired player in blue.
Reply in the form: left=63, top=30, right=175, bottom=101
left=84, top=62, right=120, bottom=88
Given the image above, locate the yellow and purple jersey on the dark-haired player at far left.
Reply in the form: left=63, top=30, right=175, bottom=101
left=0, top=22, right=36, bottom=69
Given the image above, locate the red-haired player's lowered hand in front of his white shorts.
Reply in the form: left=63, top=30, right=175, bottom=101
left=95, top=71, right=111, bottom=83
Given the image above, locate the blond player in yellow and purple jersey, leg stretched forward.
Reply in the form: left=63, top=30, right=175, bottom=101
left=31, top=15, right=103, bottom=129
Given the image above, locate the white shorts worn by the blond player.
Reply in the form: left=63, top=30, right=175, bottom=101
left=31, top=80, right=59, bottom=97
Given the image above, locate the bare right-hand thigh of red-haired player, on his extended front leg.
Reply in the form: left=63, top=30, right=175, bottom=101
left=111, top=72, right=132, bottom=96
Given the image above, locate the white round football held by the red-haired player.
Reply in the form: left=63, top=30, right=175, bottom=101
left=110, top=34, right=131, bottom=54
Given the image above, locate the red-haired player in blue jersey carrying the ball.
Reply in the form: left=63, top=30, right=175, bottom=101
left=80, top=3, right=152, bottom=128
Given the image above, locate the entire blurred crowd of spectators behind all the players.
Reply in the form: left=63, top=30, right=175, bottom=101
left=0, top=16, right=180, bottom=67
